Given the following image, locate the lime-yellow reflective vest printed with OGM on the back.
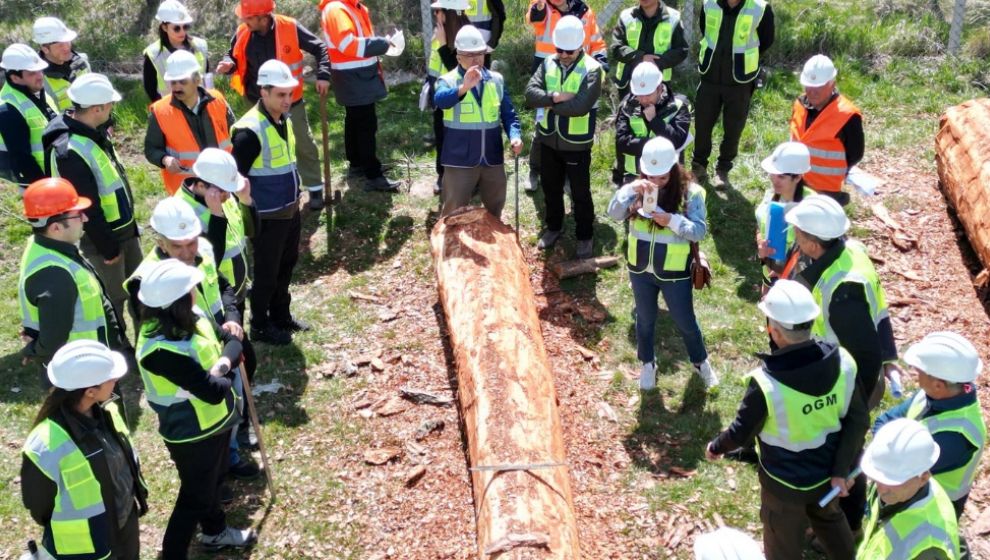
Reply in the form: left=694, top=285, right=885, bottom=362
left=748, top=348, right=856, bottom=490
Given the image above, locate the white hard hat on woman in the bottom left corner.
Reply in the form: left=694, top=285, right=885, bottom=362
left=48, top=340, right=127, bottom=391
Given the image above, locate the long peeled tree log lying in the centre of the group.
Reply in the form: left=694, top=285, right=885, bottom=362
left=431, top=209, right=580, bottom=560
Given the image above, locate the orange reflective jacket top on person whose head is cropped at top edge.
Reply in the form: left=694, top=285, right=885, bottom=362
left=320, top=0, right=378, bottom=70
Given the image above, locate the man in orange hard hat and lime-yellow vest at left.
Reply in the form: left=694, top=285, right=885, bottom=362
left=17, top=178, right=134, bottom=387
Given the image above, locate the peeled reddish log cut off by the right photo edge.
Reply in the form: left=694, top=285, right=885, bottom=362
left=935, top=98, right=990, bottom=268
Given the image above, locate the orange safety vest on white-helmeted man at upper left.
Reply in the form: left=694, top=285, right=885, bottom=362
left=151, top=89, right=233, bottom=196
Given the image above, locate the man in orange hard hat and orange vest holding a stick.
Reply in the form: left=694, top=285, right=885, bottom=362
left=217, top=0, right=330, bottom=210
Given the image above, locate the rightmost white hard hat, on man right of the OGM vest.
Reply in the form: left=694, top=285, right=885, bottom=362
left=904, top=331, right=983, bottom=383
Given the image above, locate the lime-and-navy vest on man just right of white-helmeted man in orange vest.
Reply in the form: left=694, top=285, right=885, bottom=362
left=230, top=104, right=299, bottom=212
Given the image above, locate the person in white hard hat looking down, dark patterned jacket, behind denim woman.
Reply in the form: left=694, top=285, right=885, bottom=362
left=612, top=62, right=691, bottom=186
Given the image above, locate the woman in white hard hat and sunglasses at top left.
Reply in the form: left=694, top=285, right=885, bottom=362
left=141, top=0, right=212, bottom=103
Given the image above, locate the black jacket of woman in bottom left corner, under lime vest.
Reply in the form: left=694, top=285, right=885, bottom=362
left=21, top=406, right=148, bottom=550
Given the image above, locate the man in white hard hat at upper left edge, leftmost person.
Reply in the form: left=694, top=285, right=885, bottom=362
left=0, top=43, right=58, bottom=187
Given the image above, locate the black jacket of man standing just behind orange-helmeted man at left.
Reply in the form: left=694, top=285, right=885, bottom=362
left=42, top=112, right=138, bottom=260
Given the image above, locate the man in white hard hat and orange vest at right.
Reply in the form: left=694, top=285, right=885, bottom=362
left=790, top=54, right=866, bottom=206
